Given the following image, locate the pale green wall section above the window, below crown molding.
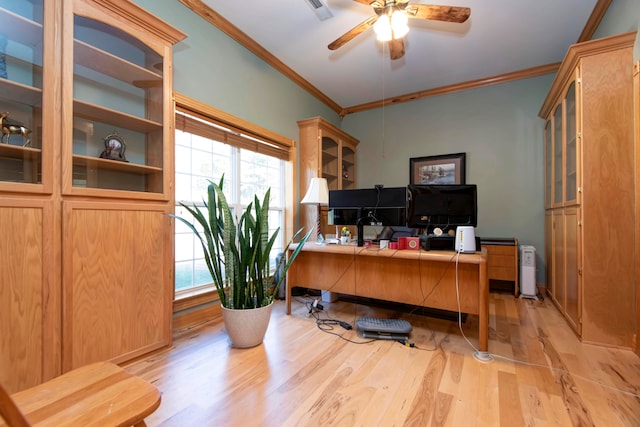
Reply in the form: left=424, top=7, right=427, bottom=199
left=134, top=0, right=339, bottom=141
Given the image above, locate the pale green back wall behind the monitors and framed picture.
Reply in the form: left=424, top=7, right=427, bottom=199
left=342, top=75, right=553, bottom=283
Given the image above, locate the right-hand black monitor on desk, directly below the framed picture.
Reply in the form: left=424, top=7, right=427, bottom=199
left=407, top=184, right=478, bottom=232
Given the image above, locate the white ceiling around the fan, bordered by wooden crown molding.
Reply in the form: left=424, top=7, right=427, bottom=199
left=203, top=0, right=597, bottom=108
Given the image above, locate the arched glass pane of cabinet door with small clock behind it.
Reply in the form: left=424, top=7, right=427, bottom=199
left=66, top=15, right=164, bottom=193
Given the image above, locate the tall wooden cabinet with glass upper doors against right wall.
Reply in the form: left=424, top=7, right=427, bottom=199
left=540, top=32, right=636, bottom=348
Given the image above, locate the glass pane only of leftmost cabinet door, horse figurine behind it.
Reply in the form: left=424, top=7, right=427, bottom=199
left=0, top=0, right=47, bottom=189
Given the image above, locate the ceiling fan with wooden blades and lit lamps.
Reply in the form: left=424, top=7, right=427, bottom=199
left=328, top=0, right=471, bottom=59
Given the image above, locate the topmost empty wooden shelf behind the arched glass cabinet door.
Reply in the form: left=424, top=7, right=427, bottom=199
left=73, top=40, right=162, bottom=88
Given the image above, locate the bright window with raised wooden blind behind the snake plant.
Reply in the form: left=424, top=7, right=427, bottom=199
left=175, top=95, right=293, bottom=298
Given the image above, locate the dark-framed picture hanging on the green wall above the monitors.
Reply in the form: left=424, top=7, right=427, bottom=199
left=409, top=153, right=466, bottom=185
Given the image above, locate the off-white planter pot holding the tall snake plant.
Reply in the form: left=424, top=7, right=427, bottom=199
left=222, top=303, right=273, bottom=348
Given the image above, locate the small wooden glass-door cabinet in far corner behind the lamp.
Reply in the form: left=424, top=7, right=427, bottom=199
left=298, top=117, right=359, bottom=236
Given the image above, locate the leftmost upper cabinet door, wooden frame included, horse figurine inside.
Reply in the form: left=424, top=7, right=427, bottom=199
left=0, top=0, right=49, bottom=192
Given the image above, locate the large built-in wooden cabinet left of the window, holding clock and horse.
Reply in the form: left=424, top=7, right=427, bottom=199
left=0, top=0, right=185, bottom=392
